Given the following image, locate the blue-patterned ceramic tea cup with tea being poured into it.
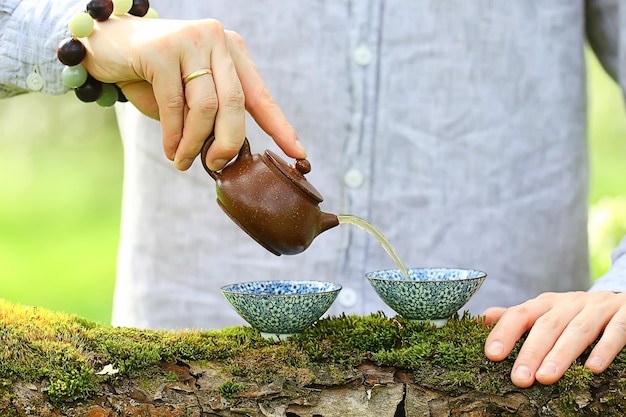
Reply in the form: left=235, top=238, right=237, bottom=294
left=366, top=268, right=487, bottom=327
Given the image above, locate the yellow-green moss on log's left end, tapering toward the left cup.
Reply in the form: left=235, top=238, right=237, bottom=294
left=0, top=300, right=268, bottom=401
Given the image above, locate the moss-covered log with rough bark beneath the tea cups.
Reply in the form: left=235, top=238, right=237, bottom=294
left=0, top=301, right=626, bottom=417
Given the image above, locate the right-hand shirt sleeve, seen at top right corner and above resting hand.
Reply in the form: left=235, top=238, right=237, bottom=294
left=586, top=0, right=626, bottom=292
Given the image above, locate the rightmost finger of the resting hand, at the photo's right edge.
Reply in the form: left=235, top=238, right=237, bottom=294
left=585, top=297, right=626, bottom=373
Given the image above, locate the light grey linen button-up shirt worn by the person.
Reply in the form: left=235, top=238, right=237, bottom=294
left=0, top=0, right=626, bottom=328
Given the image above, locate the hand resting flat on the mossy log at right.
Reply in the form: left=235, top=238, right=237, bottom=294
left=484, top=292, right=626, bottom=388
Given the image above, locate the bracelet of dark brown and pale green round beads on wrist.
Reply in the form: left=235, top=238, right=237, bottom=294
left=57, top=0, right=158, bottom=107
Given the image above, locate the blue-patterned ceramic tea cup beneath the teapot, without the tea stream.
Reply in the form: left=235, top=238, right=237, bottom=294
left=221, top=281, right=341, bottom=340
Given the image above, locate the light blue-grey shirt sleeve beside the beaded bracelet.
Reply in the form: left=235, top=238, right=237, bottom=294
left=0, top=0, right=87, bottom=98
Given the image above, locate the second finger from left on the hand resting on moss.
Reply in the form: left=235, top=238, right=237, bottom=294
left=511, top=295, right=582, bottom=388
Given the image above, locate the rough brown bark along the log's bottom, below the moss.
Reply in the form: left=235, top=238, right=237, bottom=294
left=0, top=361, right=626, bottom=417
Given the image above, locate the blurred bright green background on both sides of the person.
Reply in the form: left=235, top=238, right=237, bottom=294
left=0, top=51, right=626, bottom=323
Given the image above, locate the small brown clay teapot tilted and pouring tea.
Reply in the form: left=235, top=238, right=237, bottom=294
left=201, top=134, right=339, bottom=256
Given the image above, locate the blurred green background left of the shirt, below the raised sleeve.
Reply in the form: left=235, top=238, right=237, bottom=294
left=0, top=89, right=123, bottom=323
